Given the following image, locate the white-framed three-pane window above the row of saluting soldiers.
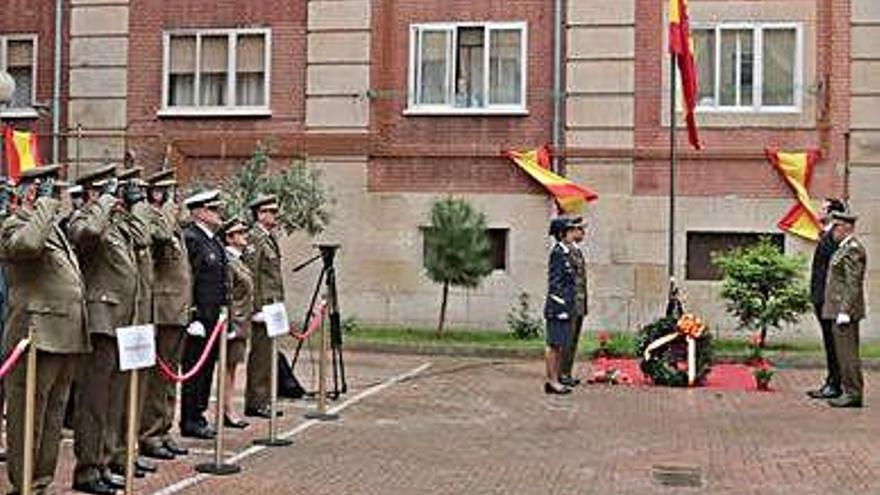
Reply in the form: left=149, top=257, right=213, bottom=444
left=160, top=29, right=272, bottom=116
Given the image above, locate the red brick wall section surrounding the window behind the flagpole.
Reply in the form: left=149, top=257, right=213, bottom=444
left=633, top=0, right=850, bottom=197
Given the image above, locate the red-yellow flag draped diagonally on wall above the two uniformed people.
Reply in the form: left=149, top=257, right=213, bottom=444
left=504, top=146, right=599, bottom=213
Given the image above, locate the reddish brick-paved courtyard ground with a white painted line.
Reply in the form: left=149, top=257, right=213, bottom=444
left=1, top=354, right=880, bottom=495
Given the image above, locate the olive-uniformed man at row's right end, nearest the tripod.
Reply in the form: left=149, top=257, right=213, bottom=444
left=244, top=195, right=284, bottom=418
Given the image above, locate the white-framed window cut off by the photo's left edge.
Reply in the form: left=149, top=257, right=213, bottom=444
left=0, top=34, right=37, bottom=117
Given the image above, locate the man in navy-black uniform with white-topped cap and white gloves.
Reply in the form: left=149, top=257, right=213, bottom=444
left=180, top=190, right=229, bottom=439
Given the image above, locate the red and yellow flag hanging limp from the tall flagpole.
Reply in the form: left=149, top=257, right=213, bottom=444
left=669, top=0, right=701, bottom=149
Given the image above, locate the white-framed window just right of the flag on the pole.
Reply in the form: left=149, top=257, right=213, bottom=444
left=692, top=23, right=804, bottom=112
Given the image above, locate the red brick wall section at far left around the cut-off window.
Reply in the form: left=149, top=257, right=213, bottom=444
left=0, top=0, right=70, bottom=173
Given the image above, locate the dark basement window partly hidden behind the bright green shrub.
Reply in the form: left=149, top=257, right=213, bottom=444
left=687, top=232, right=785, bottom=280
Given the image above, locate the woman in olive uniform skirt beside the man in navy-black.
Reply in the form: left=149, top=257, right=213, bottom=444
left=223, top=218, right=254, bottom=428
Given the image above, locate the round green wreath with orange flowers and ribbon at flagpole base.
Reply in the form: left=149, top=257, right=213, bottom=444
left=636, top=314, right=712, bottom=387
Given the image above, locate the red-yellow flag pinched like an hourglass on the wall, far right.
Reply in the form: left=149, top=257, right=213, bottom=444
left=765, top=148, right=822, bottom=241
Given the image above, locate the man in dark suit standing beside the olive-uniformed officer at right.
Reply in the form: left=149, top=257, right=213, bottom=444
left=807, top=198, right=845, bottom=399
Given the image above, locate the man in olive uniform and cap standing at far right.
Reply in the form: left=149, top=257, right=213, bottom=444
left=822, top=211, right=867, bottom=407
